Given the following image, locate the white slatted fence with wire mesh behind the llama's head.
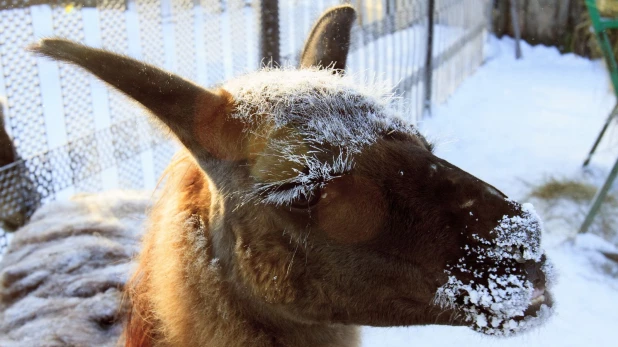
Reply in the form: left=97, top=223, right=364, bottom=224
left=0, top=0, right=490, bottom=254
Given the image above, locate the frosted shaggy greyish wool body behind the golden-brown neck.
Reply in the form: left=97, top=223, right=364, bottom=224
left=0, top=192, right=150, bottom=347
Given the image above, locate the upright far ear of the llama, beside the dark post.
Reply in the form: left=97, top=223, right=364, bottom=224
left=300, top=5, right=356, bottom=70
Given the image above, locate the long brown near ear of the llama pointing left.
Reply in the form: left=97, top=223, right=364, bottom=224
left=29, top=39, right=242, bottom=160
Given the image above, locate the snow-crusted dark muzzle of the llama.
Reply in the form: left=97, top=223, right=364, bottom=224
left=435, top=199, right=553, bottom=336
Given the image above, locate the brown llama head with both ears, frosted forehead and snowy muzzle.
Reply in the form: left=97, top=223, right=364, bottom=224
left=32, top=6, right=551, bottom=335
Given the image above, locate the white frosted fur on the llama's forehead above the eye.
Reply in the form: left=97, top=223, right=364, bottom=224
left=224, top=68, right=418, bottom=205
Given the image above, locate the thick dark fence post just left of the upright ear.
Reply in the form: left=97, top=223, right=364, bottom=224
left=259, top=0, right=280, bottom=64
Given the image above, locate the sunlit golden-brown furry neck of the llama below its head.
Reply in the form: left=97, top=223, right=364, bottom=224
left=132, top=160, right=358, bottom=347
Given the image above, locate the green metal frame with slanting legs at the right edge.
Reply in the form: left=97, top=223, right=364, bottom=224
left=579, top=0, right=618, bottom=233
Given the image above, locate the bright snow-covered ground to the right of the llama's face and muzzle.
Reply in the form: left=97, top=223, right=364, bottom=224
left=363, top=39, right=618, bottom=347
